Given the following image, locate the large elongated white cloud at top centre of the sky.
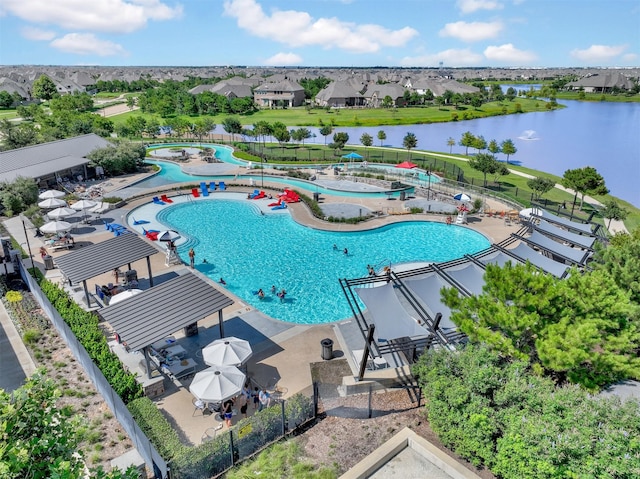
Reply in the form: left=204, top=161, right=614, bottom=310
left=224, top=0, right=418, bottom=53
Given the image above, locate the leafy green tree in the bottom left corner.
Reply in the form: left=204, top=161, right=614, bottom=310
left=0, top=371, right=138, bottom=479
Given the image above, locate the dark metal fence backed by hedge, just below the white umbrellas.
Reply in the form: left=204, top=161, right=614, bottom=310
left=169, top=392, right=316, bottom=479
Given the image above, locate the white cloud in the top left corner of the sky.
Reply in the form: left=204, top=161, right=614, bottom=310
left=2, top=0, right=182, bottom=33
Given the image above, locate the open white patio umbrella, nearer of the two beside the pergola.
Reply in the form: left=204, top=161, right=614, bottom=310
left=189, top=366, right=246, bottom=402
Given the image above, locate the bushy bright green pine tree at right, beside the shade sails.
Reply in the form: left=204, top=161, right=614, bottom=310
left=442, top=263, right=640, bottom=390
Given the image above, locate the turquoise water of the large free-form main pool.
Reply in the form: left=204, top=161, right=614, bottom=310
left=158, top=199, right=490, bottom=324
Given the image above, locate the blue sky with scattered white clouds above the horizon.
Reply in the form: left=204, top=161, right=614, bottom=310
left=0, top=0, right=640, bottom=68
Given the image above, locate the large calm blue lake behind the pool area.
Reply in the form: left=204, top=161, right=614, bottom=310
left=294, top=94, right=640, bottom=207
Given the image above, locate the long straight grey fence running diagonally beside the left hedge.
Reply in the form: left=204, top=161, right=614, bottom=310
left=18, top=261, right=168, bottom=477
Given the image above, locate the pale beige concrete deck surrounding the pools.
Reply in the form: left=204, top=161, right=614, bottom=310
left=5, top=157, right=517, bottom=450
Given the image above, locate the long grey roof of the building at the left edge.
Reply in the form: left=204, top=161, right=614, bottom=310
left=0, top=133, right=110, bottom=181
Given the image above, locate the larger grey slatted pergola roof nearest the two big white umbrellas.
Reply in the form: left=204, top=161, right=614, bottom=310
left=98, top=274, right=233, bottom=351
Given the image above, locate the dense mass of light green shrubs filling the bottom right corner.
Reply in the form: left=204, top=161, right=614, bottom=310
left=413, top=346, right=640, bottom=479
